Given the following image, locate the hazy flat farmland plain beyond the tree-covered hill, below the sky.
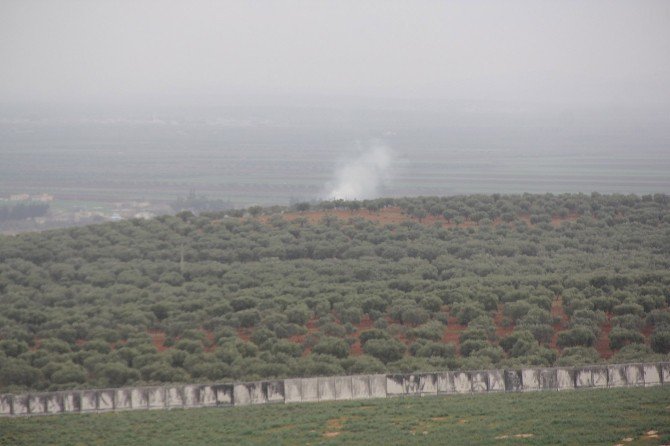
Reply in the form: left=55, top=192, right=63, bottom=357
left=0, top=109, right=670, bottom=206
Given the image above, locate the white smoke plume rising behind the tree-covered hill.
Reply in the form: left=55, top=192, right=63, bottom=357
left=326, top=144, right=392, bottom=200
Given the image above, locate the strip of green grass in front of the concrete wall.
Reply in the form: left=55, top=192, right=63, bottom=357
left=0, top=386, right=670, bottom=446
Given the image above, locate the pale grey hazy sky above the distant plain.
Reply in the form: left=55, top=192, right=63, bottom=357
left=0, top=0, right=670, bottom=107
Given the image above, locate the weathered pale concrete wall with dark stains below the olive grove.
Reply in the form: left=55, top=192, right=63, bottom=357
left=0, top=362, right=670, bottom=417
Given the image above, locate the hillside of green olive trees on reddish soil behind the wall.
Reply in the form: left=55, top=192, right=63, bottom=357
left=0, top=194, right=670, bottom=392
